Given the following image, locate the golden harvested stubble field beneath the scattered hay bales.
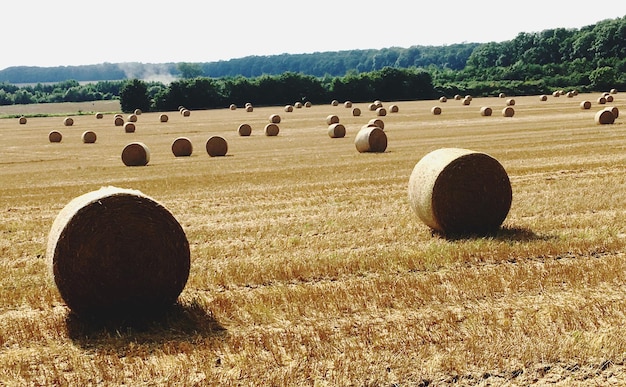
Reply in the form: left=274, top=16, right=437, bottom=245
left=0, top=94, right=626, bottom=386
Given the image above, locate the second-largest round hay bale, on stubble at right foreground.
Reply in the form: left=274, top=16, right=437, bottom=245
left=409, top=148, right=513, bottom=235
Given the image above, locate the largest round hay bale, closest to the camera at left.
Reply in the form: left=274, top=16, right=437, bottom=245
left=46, top=187, right=190, bottom=319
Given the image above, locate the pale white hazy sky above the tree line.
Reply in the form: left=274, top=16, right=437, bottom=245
left=0, top=0, right=626, bottom=69
